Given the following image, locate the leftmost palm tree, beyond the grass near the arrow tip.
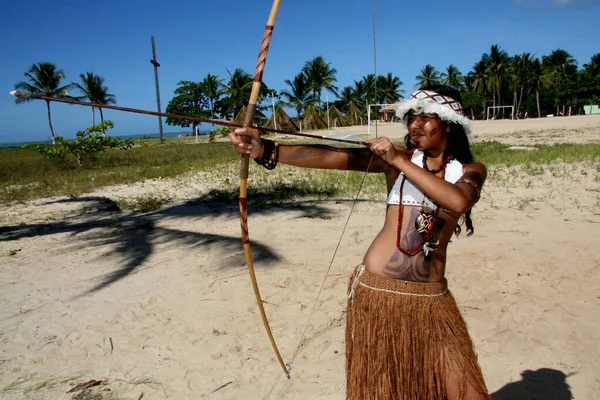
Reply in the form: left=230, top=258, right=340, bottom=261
left=15, top=63, right=71, bottom=144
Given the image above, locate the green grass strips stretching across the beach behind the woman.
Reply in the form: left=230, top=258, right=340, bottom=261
left=0, top=141, right=600, bottom=206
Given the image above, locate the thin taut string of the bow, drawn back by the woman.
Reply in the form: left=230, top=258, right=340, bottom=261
left=287, top=0, right=379, bottom=372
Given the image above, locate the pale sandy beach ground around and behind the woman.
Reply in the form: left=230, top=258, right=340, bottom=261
left=0, top=115, right=600, bottom=400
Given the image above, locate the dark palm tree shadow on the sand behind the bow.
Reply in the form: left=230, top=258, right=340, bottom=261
left=0, top=187, right=366, bottom=293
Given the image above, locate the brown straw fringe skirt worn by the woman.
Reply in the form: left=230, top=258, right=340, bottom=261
left=346, top=265, right=490, bottom=400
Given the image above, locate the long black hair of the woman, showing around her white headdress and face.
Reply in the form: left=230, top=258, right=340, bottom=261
left=404, top=85, right=475, bottom=236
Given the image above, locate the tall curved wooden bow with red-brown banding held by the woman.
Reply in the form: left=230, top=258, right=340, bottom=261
left=240, top=0, right=290, bottom=379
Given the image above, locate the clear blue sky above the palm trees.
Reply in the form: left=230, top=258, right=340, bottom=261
left=0, top=0, right=600, bottom=142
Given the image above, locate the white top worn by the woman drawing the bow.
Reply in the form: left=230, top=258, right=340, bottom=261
left=388, top=150, right=463, bottom=208
